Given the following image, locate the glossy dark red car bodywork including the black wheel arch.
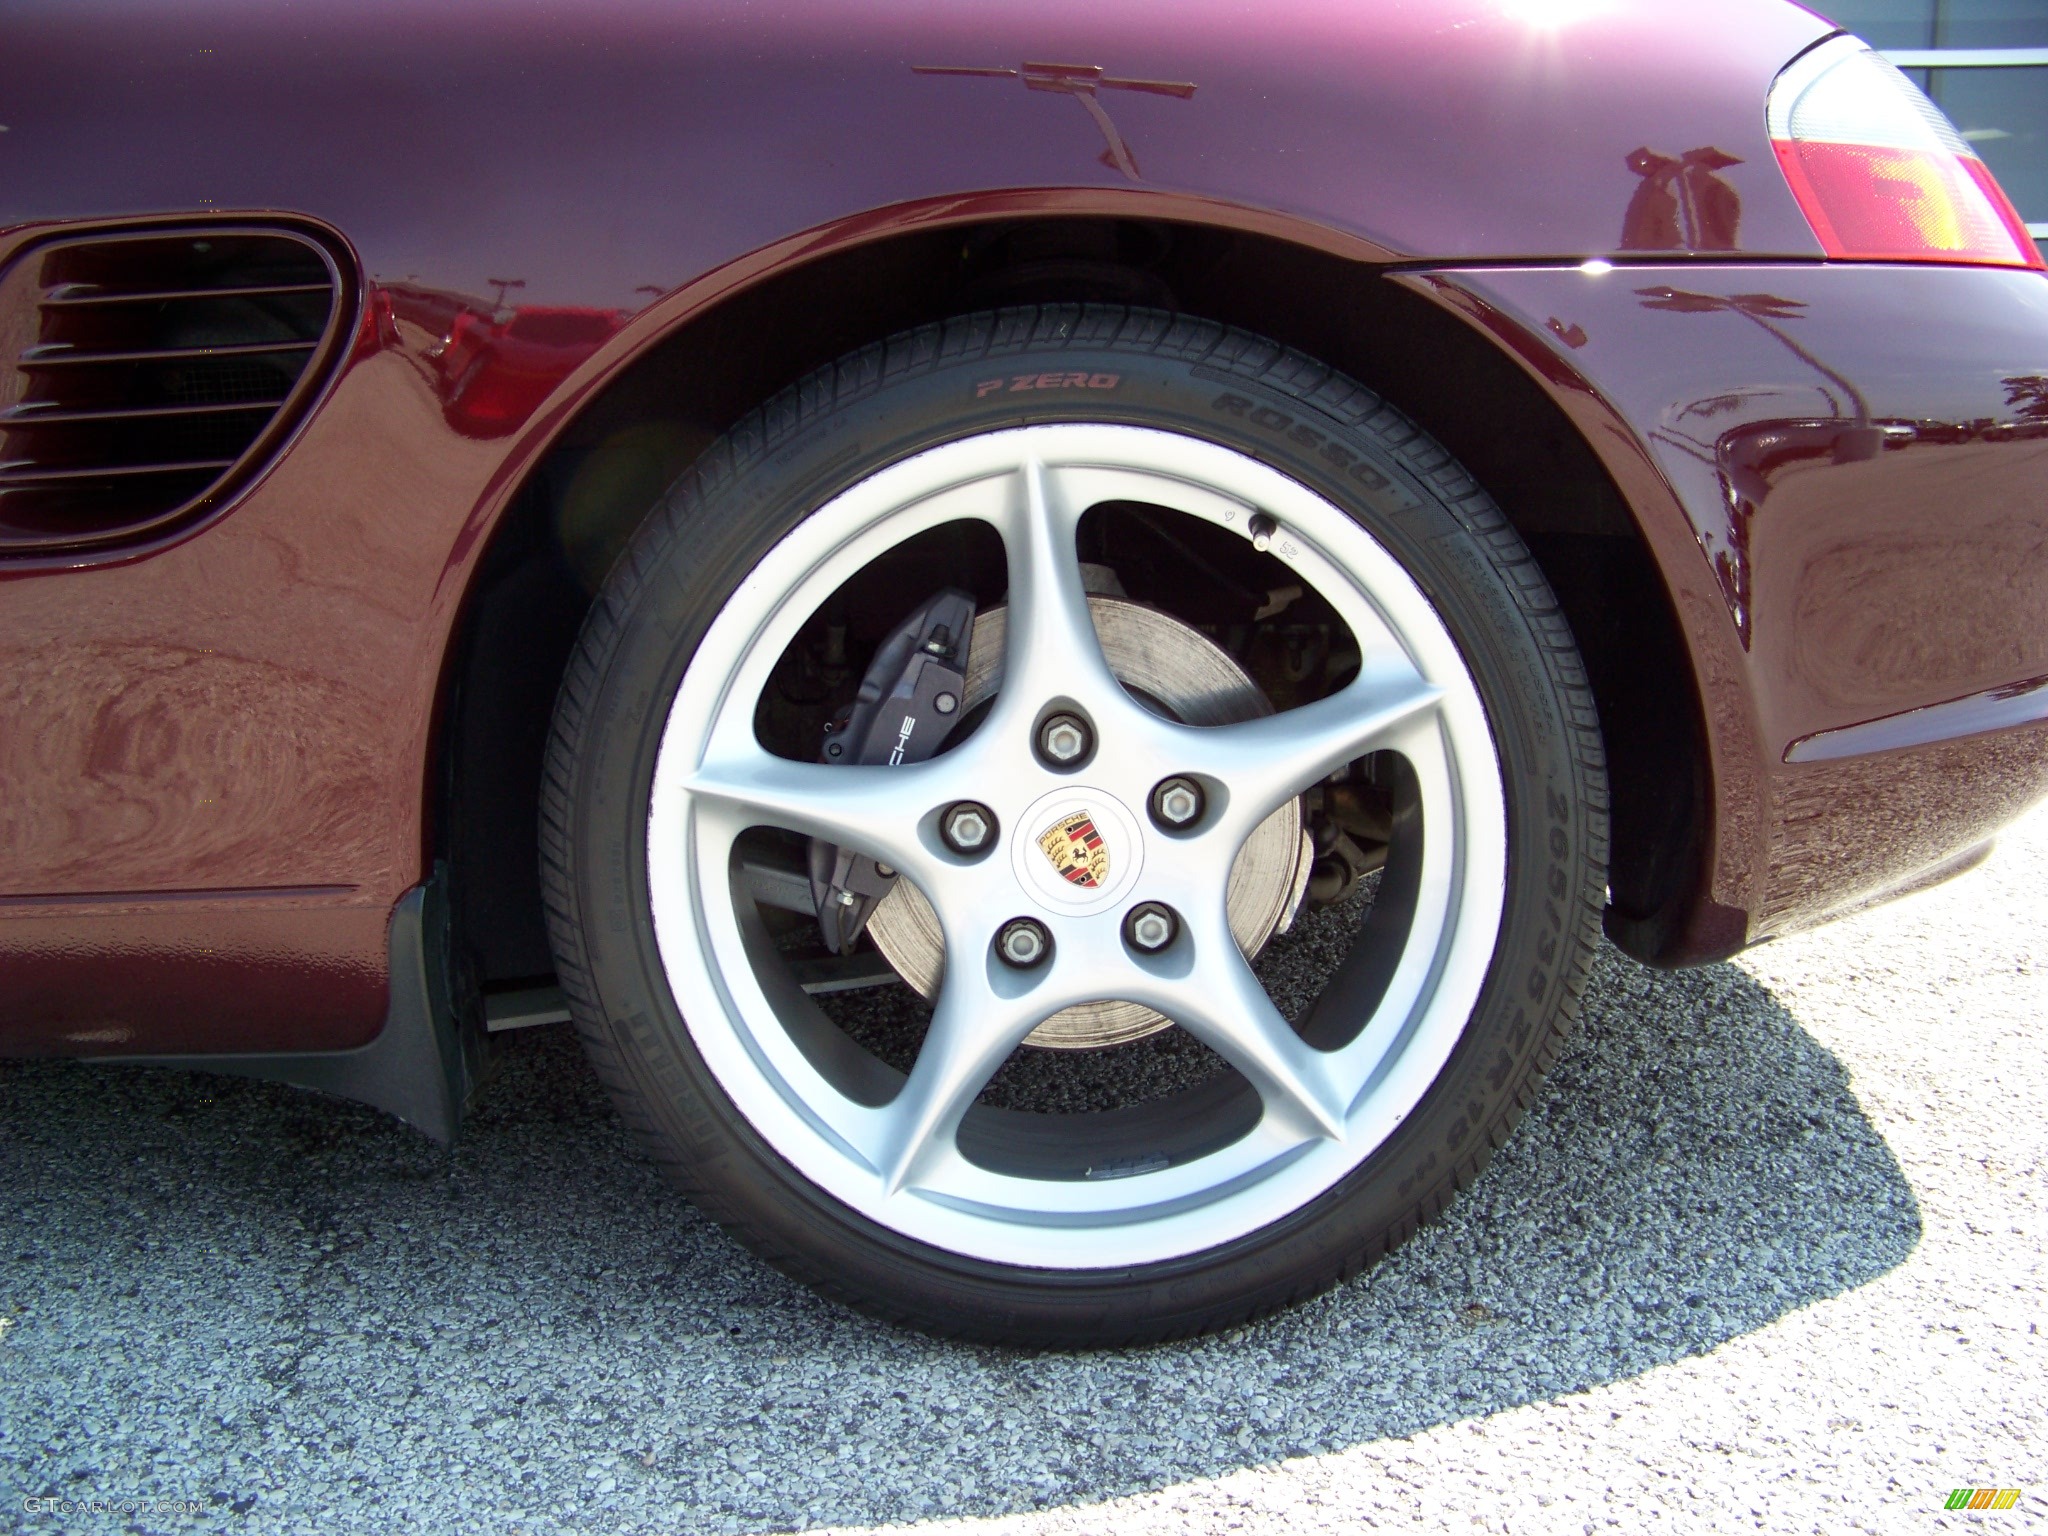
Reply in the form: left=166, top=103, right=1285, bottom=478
left=0, top=0, right=2048, bottom=1118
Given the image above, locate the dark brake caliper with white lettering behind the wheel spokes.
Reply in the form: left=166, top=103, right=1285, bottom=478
left=811, top=588, right=975, bottom=954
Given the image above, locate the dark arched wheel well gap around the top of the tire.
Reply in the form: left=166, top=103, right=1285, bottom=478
left=434, top=219, right=1710, bottom=983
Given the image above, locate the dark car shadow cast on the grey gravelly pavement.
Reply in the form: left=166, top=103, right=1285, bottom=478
left=0, top=950, right=1919, bottom=1532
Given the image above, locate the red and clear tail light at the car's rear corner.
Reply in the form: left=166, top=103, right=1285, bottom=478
left=1767, top=37, right=2042, bottom=268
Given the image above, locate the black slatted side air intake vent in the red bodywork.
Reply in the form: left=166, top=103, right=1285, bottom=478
left=0, top=227, right=342, bottom=555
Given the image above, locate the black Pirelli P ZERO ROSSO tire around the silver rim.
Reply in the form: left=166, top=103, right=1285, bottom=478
left=541, top=305, right=1608, bottom=1346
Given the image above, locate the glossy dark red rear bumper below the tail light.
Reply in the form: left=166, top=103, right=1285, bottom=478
left=1407, top=264, right=2048, bottom=963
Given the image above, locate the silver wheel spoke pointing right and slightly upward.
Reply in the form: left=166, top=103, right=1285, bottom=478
left=1165, top=659, right=1444, bottom=840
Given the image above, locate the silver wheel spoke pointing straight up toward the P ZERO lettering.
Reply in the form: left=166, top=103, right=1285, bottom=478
left=997, top=459, right=1124, bottom=711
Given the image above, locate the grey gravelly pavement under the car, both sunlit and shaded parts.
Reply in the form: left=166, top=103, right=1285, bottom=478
left=0, top=813, right=2048, bottom=1536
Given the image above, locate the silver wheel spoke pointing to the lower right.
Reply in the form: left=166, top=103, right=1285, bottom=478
left=1143, top=920, right=1350, bottom=1141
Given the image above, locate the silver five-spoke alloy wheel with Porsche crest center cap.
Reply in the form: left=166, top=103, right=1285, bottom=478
left=647, top=422, right=1507, bottom=1270
